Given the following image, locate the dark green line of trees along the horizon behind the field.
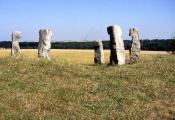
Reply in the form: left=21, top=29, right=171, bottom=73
left=0, top=39, right=175, bottom=51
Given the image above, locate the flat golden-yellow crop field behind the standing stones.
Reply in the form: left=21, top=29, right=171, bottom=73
left=0, top=49, right=168, bottom=64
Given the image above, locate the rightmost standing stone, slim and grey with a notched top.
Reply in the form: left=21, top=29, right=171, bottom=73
left=129, top=28, right=140, bottom=63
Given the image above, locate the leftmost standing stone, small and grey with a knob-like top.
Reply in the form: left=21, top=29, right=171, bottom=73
left=11, top=31, right=21, bottom=56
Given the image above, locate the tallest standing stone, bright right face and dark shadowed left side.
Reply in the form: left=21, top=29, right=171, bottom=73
left=107, top=25, right=125, bottom=65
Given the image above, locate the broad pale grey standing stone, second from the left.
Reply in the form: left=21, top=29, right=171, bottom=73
left=38, top=29, right=52, bottom=59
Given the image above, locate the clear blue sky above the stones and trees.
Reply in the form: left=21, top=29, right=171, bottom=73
left=0, top=0, right=175, bottom=41
